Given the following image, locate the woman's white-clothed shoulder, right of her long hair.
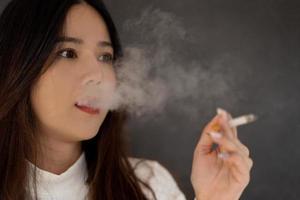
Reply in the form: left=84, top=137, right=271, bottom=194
left=128, top=157, right=186, bottom=200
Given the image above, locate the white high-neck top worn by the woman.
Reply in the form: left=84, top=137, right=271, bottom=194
left=28, top=153, right=186, bottom=200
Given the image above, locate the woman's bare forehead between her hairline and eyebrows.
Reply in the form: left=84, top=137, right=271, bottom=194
left=64, top=3, right=110, bottom=41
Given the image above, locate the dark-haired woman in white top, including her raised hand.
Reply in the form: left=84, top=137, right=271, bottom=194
left=0, top=0, right=252, bottom=200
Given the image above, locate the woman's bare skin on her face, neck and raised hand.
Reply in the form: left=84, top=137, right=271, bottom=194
left=31, top=3, right=252, bottom=200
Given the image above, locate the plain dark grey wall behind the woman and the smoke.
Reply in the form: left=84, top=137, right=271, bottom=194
left=0, top=0, right=300, bottom=200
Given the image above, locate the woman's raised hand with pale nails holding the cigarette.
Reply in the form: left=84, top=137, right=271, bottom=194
left=191, top=109, right=253, bottom=200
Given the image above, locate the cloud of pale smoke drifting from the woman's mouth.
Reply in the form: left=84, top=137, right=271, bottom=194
left=78, top=8, right=238, bottom=120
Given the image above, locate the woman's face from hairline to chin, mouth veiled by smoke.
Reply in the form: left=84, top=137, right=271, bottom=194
left=31, top=3, right=116, bottom=142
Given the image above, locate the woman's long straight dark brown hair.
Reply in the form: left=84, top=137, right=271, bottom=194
left=0, top=0, right=155, bottom=200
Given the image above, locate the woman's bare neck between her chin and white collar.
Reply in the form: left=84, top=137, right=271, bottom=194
left=36, top=138, right=82, bottom=175
